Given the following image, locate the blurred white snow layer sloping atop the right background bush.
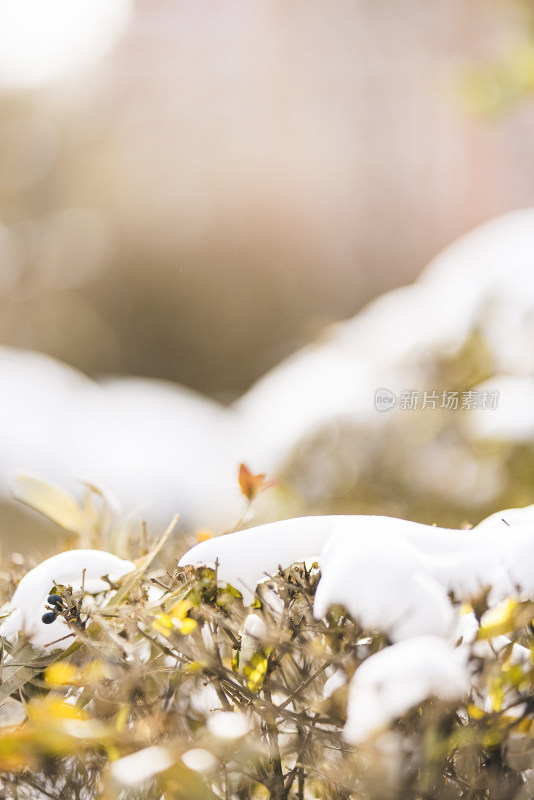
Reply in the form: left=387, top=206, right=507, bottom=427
left=239, top=209, right=534, bottom=471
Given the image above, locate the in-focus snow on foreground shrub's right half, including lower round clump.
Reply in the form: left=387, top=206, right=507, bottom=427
left=180, top=506, right=534, bottom=744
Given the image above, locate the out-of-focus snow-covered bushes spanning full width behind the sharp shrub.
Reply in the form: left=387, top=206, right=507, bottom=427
left=0, top=209, right=534, bottom=528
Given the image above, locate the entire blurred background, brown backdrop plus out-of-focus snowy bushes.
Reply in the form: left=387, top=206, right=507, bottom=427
left=0, top=0, right=534, bottom=556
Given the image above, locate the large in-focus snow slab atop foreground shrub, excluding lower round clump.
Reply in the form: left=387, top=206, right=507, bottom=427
left=179, top=510, right=534, bottom=641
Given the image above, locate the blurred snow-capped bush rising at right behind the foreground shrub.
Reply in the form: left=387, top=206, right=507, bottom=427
left=235, top=209, right=534, bottom=525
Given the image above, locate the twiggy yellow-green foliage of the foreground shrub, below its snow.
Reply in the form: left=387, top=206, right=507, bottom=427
left=0, top=524, right=534, bottom=800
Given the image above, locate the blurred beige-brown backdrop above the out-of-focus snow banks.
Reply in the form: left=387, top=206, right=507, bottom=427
left=0, top=0, right=534, bottom=403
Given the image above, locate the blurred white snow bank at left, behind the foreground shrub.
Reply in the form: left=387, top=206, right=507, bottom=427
left=0, top=347, right=243, bottom=525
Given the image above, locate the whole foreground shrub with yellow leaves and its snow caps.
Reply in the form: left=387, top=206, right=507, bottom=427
left=0, top=488, right=534, bottom=800
